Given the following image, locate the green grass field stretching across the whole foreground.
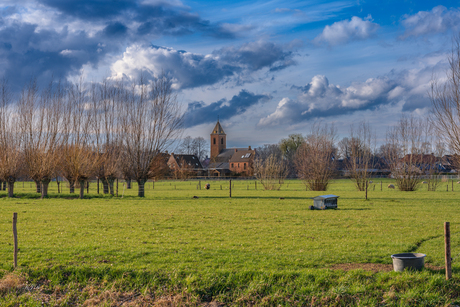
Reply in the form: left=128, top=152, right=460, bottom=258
left=0, top=179, right=460, bottom=306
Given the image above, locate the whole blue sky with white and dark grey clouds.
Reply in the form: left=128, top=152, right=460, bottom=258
left=0, top=0, right=460, bottom=147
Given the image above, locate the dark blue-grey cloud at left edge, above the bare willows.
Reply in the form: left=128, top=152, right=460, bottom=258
left=0, top=23, right=106, bottom=91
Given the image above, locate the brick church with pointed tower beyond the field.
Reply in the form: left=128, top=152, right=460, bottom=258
left=208, top=121, right=256, bottom=176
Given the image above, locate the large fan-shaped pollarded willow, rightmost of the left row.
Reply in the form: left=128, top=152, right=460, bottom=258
left=120, top=74, right=182, bottom=197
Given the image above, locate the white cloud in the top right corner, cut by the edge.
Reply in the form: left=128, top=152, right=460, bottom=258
left=400, top=5, right=460, bottom=39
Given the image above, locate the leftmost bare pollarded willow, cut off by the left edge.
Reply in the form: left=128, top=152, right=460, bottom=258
left=0, top=79, right=23, bottom=197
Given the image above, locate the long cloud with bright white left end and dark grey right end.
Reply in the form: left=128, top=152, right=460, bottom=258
left=118, top=41, right=295, bottom=89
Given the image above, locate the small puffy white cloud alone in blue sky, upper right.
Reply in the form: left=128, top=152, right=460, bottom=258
left=313, top=15, right=379, bottom=46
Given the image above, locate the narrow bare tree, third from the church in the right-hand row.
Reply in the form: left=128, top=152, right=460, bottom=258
left=342, top=122, right=375, bottom=191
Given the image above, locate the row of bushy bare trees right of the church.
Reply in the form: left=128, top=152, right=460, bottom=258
left=255, top=116, right=444, bottom=191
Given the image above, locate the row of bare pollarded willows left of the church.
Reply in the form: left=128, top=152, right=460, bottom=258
left=0, top=76, right=182, bottom=198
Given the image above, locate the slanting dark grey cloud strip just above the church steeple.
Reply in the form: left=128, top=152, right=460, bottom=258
left=184, top=90, right=270, bottom=128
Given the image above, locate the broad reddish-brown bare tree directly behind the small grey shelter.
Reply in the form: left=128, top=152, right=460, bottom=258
left=295, top=124, right=337, bottom=191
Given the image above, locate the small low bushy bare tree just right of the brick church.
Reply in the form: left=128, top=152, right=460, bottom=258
left=254, top=154, right=289, bottom=190
